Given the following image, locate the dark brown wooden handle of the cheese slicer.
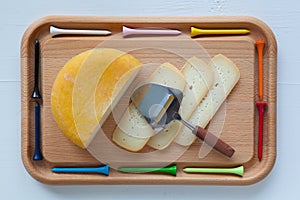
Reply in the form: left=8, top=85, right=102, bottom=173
left=194, top=126, right=235, bottom=157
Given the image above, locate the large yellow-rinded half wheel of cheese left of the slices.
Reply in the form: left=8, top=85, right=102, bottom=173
left=51, top=48, right=141, bottom=148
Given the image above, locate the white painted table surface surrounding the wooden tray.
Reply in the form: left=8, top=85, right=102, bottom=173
left=0, top=0, right=300, bottom=200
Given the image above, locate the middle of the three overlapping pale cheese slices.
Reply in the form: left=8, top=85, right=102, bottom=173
left=147, top=57, right=214, bottom=149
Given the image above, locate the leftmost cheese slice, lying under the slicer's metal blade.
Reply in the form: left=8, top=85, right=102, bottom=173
left=112, top=63, right=186, bottom=152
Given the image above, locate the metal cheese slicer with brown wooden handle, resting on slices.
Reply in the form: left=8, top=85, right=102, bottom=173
left=131, top=83, right=235, bottom=157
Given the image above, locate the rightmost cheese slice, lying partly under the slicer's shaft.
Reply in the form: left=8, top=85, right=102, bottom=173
left=175, top=54, right=240, bottom=146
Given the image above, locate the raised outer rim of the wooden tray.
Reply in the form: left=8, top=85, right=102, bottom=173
left=20, top=15, right=277, bottom=185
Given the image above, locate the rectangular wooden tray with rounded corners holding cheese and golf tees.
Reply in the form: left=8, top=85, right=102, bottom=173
left=21, top=16, right=277, bottom=185
